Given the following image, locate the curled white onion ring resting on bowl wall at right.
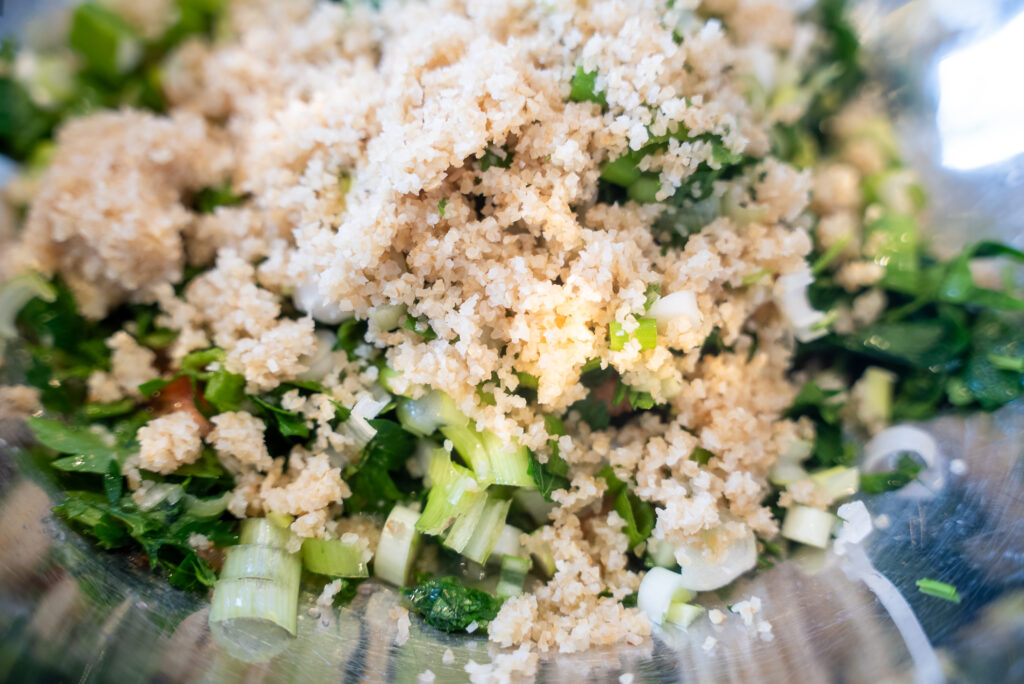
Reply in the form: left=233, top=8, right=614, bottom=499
left=862, top=425, right=946, bottom=499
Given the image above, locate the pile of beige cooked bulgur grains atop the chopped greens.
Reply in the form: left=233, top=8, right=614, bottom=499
left=4, top=0, right=847, bottom=659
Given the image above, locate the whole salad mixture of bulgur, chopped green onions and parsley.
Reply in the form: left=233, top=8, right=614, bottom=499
left=0, top=0, right=1024, bottom=673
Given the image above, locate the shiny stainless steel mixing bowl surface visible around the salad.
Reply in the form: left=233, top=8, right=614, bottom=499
left=0, top=0, right=1024, bottom=682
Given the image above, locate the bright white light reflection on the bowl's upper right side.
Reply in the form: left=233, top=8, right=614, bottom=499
left=938, top=9, right=1024, bottom=170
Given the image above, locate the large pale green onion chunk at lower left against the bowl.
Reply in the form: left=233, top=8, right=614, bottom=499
left=210, top=518, right=302, bottom=662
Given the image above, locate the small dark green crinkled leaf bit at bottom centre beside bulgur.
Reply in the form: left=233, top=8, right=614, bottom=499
left=402, top=578, right=502, bottom=632
